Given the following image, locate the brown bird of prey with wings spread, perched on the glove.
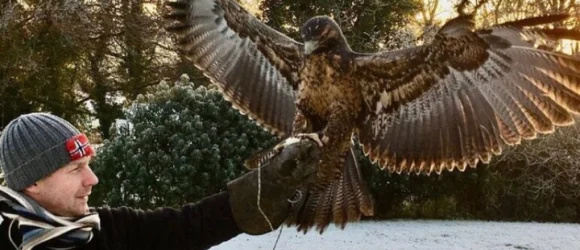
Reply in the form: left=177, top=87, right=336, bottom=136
left=165, top=0, right=580, bottom=233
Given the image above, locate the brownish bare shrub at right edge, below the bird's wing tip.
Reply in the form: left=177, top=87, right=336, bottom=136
left=482, top=121, right=580, bottom=221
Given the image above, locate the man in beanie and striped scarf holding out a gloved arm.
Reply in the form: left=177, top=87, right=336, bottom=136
left=0, top=113, right=318, bottom=250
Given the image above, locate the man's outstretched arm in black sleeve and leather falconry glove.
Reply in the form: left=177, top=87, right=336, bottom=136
left=95, top=139, right=319, bottom=249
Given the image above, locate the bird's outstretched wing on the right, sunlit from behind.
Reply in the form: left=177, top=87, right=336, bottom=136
left=354, top=15, right=580, bottom=173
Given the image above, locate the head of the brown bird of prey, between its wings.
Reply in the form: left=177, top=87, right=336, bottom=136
left=300, top=16, right=350, bottom=55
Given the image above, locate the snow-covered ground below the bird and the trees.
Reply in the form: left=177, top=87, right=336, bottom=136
left=211, top=220, right=580, bottom=250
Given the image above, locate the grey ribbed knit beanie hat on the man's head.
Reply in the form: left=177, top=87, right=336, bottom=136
left=0, top=113, right=86, bottom=191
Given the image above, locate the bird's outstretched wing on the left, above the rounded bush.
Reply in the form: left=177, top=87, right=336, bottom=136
left=165, top=0, right=303, bottom=137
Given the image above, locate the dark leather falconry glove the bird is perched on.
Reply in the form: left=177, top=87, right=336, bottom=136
left=227, top=138, right=320, bottom=235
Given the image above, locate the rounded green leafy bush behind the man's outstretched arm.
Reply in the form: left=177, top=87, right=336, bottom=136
left=92, top=77, right=276, bottom=208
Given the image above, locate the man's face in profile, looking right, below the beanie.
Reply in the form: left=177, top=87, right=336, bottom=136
left=27, top=156, right=99, bottom=217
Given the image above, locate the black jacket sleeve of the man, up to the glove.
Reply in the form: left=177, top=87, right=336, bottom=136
left=97, top=192, right=242, bottom=249
